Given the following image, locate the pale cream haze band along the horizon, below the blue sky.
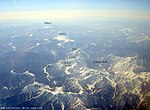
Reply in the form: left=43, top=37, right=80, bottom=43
left=0, top=10, right=150, bottom=20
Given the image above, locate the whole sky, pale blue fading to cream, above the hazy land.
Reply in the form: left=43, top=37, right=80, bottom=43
left=0, top=0, right=150, bottom=19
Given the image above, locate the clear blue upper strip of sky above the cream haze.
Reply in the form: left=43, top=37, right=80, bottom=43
left=0, top=0, right=150, bottom=12
